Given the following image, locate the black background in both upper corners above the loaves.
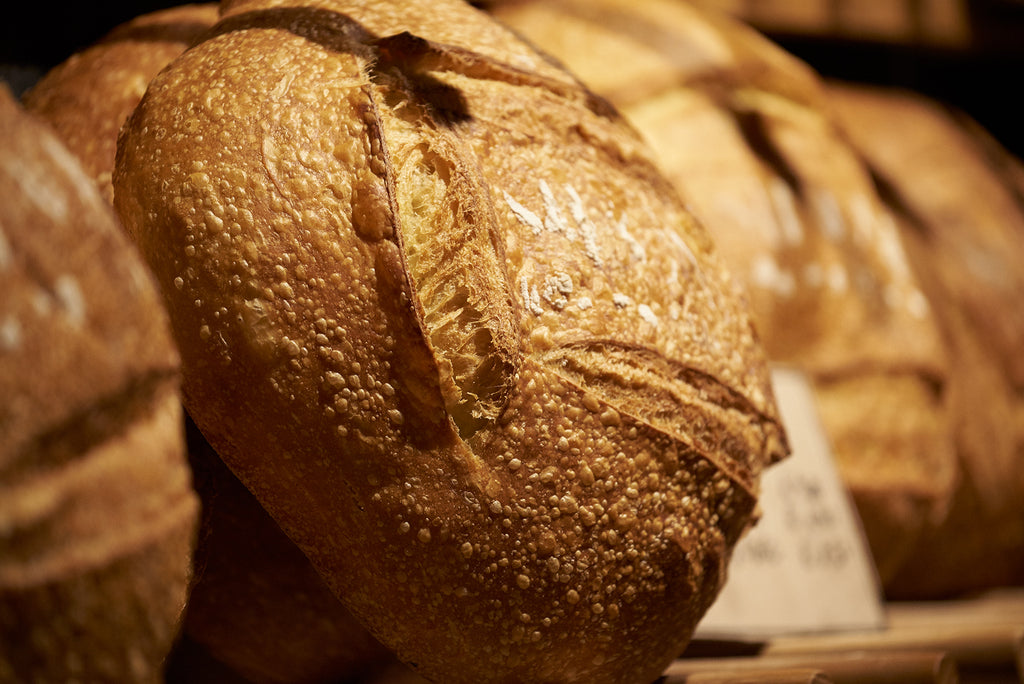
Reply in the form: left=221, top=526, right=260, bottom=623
left=6, top=0, right=1024, bottom=157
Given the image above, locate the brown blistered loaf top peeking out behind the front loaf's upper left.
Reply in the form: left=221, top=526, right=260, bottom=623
left=22, top=3, right=217, bottom=202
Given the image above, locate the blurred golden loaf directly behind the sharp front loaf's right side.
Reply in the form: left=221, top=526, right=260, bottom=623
left=493, top=0, right=957, bottom=582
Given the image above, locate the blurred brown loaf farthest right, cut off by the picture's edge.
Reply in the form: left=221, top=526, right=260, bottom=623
left=829, top=83, right=1024, bottom=598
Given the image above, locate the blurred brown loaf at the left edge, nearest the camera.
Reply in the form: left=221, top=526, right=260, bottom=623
left=0, top=88, right=198, bottom=682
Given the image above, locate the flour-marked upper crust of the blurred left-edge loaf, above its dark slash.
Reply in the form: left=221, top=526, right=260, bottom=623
left=0, top=91, right=177, bottom=481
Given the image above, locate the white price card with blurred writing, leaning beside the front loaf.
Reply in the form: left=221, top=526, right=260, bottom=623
left=695, top=368, right=885, bottom=639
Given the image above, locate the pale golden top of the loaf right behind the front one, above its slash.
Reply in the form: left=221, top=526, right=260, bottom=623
left=488, top=0, right=822, bottom=114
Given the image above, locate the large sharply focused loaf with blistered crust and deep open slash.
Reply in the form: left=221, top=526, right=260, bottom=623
left=114, top=1, right=785, bottom=682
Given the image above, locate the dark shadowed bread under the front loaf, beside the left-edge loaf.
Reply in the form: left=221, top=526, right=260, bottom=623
left=176, top=421, right=394, bottom=684
